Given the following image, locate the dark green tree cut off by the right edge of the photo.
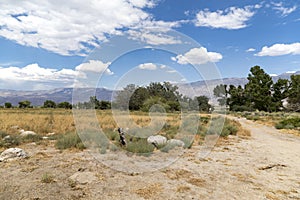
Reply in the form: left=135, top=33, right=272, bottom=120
left=288, top=75, right=300, bottom=112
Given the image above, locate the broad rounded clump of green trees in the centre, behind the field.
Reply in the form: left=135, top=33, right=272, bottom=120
left=114, top=82, right=212, bottom=112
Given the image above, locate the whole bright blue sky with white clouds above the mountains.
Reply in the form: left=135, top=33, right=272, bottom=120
left=0, top=0, right=300, bottom=90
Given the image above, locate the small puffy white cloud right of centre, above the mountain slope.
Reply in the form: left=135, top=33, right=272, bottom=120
left=171, top=47, right=223, bottom=65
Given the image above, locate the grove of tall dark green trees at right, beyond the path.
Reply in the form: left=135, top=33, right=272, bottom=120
left=214, top=66, right=300, bottom=112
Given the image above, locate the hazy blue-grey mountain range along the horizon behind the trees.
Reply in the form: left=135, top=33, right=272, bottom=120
left=0, top=71, right=300, bottom=106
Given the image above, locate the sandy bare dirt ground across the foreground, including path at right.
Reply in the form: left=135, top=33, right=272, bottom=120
left=0, top=118, right=300, bottom=200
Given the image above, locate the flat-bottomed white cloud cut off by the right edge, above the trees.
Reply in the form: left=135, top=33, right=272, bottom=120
left=255, top=42, right=300, bottom=56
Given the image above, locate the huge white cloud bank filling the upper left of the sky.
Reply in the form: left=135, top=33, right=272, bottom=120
left=0, top=0, right=158, bottom=55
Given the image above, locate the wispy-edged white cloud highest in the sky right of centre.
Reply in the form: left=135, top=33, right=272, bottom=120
left=195, top=6, right=259, bottom=29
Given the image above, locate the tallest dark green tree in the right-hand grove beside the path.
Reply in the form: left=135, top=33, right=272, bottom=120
left=245, top=66, right=274, bottom=111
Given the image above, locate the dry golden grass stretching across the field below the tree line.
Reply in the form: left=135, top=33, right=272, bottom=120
left=0, top=109, right=250, bottom=152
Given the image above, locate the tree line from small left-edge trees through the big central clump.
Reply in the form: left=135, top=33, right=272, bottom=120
left=4, top=82, right=212, bottom=112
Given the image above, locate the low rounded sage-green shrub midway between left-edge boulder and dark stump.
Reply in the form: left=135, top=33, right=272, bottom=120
left=55, top=132, right=85, bottom=150
